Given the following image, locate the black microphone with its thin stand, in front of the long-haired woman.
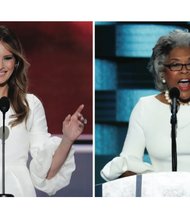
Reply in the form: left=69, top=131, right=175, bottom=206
left=0, top=96, right=14, bottom=197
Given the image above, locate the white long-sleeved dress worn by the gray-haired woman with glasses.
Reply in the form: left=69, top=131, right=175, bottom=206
left=100, top=96, right=190, bottom=181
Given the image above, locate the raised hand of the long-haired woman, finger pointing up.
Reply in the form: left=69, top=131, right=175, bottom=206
left=62, top=105, right=87, bottom=143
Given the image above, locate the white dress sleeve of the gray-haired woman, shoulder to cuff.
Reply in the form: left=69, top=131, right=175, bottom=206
left=100, top=101, right=153, bottom=181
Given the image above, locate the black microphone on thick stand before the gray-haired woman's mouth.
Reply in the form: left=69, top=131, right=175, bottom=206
left=169, top=87, right=180, bottom=171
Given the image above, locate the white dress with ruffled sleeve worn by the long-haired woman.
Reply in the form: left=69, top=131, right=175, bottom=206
left=0, top=94, right=75, bottom=197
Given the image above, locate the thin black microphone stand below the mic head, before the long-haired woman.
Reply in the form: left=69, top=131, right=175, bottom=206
left=0, top=97, right=14, bottom=197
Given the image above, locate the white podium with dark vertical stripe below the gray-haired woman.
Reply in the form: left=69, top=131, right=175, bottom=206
left=96, top=172, right=190, bottom=197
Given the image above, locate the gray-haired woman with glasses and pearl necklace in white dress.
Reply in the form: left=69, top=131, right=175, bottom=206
left=101, top=30, right=190, bottom=181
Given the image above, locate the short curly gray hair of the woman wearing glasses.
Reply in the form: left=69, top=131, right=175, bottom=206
left=148, top=30, right=190, bottom=91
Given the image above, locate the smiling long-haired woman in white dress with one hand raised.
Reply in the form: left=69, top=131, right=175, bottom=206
left=0, top=26, right=87, bottom=196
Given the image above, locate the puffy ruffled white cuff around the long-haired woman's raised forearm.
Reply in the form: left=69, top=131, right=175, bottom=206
left=30, top=137, right=75, bottom=195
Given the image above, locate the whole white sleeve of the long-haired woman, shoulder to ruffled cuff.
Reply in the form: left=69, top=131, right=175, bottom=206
left=29, top=96, right=75, bottom=195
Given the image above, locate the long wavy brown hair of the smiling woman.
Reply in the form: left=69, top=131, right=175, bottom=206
left=0, top=26, right=29, bottom=127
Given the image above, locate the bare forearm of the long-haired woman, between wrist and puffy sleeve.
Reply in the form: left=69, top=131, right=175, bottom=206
left=46, top=137, right=73, bottom=179
